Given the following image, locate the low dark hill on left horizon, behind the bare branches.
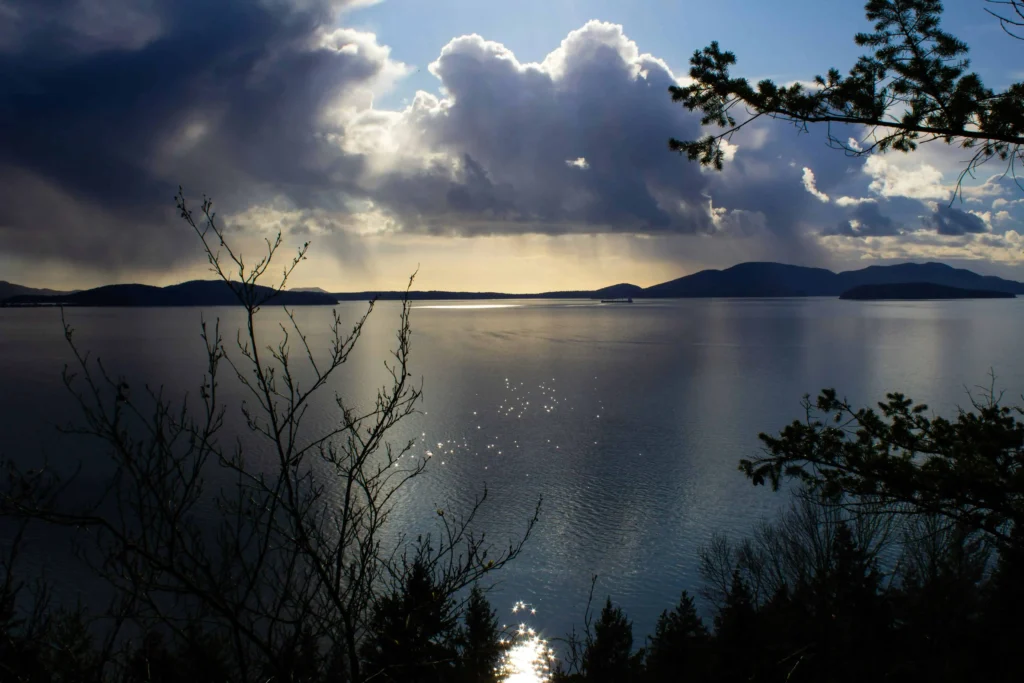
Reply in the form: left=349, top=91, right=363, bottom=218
left=2, top=280, right=337, bottom=306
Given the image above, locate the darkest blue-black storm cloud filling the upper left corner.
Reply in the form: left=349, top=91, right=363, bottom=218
left=0, top=0, right=386, bottom=266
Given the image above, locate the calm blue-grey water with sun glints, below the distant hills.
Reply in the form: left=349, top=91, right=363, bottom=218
left=0, top=299, right=1024, bottom=638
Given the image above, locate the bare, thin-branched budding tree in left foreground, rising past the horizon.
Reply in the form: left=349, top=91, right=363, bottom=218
left=0, top=191, right=537, bottom=683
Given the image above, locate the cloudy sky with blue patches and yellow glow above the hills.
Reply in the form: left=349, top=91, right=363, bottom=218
left=0, top=0, right=1024, bottom=292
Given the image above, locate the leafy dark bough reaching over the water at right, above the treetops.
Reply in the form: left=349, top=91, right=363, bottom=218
left=739, top=389, right=1024, bottom=550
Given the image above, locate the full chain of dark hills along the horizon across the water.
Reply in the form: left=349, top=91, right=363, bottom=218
left=0, top=261, right=1024, bottom=306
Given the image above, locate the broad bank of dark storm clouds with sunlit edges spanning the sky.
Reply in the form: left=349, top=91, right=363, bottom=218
left=6, top=6, right=995, bottom=268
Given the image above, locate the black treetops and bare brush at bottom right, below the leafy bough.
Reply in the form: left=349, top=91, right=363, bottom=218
left=532, top=489, right=1024, bottom=683
